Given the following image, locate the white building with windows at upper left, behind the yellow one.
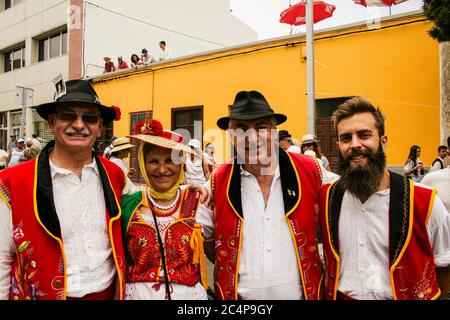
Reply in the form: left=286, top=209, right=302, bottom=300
left=0, top=0, right=257, bottom=149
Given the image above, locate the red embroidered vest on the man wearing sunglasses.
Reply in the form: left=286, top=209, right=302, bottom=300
left=0, top=149, right=125, bottom=300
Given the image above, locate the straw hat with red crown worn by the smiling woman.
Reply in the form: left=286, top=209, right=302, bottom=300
left=130, top=120, right=192, bottom=153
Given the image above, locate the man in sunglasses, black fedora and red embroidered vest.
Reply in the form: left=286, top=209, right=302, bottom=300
left=0, top=80, right=125, bottom=300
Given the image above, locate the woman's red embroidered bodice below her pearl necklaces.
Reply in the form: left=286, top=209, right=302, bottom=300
left=127, top=190, right=200, bottom=287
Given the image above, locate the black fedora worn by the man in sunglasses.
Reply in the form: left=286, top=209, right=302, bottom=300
left=36, top=80, right=120, bottom=123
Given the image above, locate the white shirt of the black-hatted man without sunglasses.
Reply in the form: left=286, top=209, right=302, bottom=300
left=203, top=168, right=303, bottom=300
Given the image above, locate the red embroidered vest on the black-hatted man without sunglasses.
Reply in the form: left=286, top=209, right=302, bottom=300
left=211, top=150, right=323, bottom=300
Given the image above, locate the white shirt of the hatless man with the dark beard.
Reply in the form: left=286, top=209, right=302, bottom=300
left=338, top=185, right=450, bottom=300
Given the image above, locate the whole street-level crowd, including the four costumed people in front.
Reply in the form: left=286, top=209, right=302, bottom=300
left=0, top=80, right=450, bottom=300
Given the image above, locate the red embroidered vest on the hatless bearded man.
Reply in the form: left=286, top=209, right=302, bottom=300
left=320, top=172, right=440, bottom=300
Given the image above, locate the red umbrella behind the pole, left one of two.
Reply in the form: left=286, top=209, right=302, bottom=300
left=280, top=1, right=336, bottom=26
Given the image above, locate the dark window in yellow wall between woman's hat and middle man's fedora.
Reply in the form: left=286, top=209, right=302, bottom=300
left=172, top=106, right=203, bottom=143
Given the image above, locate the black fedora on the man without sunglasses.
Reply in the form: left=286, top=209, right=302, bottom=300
left=217, top=91, right=287, bottom=130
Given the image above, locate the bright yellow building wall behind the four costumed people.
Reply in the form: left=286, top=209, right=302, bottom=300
left=95, top=16, right=439, bottom=166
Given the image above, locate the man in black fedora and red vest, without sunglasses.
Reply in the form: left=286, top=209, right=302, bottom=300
left=199, top=91, right=322, bottom=300
